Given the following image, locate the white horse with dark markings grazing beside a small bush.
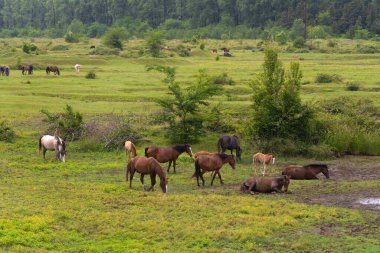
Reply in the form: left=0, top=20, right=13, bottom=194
left=38, top=135, right=66, bottom=162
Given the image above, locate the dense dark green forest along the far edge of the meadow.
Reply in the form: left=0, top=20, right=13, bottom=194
left=0, top=0, right=380, bottom=38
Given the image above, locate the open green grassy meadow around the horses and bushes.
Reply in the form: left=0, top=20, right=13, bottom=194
left=0, top=39, right=380, bottom=252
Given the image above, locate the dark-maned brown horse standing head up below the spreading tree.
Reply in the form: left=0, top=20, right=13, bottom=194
left=145, top=144, right=193, bottom=173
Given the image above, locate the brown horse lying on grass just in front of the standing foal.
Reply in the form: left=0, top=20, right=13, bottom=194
left=240, top=175, right=290, bottom=194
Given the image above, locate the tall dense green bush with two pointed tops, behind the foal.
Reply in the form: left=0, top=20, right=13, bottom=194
left=249, top=49, right=313, bottom=146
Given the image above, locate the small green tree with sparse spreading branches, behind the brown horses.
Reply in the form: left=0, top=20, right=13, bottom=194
left=147, top=65, right=222, bottom=143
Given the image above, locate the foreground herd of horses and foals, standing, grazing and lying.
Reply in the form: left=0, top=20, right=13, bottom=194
left=39, top=134, right=329, bottom=194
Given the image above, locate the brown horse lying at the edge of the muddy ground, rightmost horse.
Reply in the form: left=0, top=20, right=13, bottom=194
left=282, top=164, right=330, bottom=180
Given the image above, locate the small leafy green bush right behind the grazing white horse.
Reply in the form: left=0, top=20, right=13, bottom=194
left=41, top=104, right=84, bottom=141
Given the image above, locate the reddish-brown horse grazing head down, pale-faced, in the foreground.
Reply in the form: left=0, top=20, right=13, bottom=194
left=125, top=156, right=168, bottom=193
